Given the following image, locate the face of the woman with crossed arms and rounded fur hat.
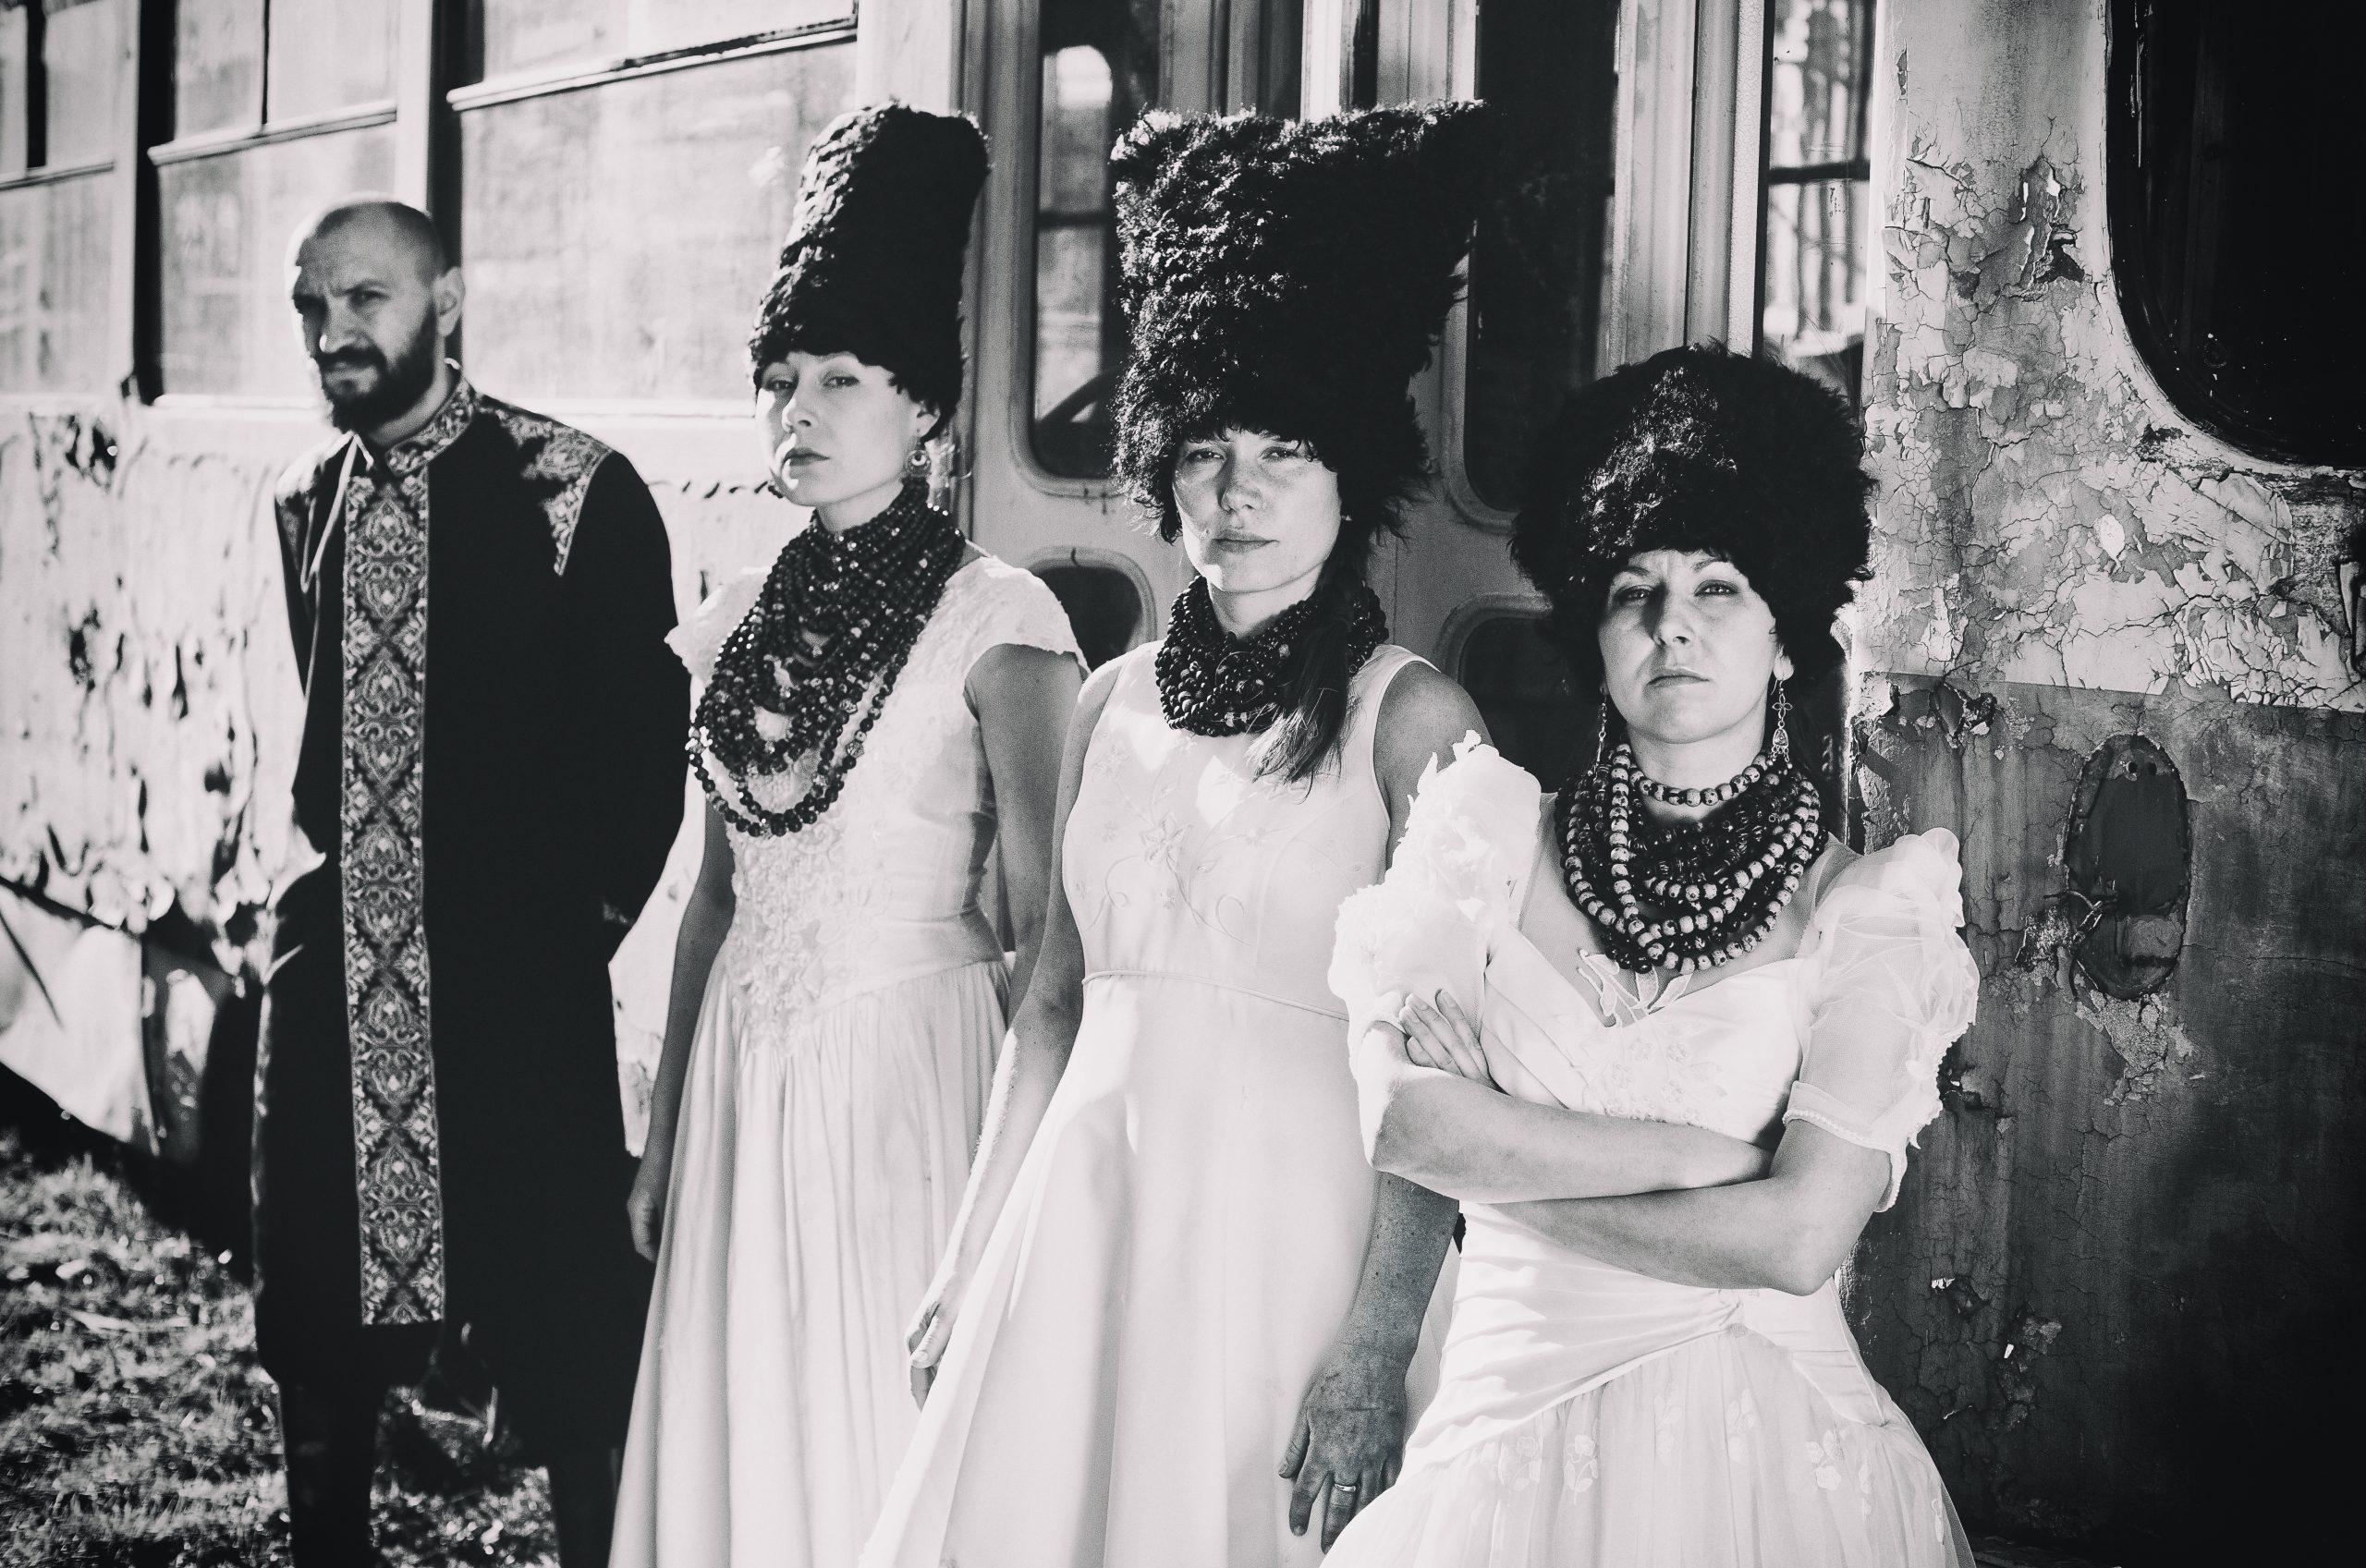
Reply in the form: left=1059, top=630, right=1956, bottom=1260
left=1597, top=551, right=1791, bottom=749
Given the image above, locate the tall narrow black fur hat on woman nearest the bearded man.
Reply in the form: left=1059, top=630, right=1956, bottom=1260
left=748, top=104, right=987, bottom=414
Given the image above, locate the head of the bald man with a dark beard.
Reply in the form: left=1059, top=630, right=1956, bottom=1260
left=288, top=215, right=461, bottom=431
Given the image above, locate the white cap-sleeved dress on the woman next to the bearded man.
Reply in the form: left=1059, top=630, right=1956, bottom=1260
left=610, top=556, right=1077, bottom=1568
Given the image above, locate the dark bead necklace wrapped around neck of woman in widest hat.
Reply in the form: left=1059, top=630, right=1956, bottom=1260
left=1154, top=577, right=1389, bottom=735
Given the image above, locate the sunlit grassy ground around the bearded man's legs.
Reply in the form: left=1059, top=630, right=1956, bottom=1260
left=0, top=1128, right=556, bottom=1568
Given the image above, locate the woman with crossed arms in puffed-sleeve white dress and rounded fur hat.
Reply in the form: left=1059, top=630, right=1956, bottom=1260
left=1330, top=350, right=1978, bottom=1568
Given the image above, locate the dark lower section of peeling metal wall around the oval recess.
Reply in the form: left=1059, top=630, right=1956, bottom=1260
left=1848, top=676, right=2366, bottom=1561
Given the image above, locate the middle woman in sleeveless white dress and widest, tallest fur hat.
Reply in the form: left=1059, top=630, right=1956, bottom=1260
left=863, top=104, right=1543, bottom=1568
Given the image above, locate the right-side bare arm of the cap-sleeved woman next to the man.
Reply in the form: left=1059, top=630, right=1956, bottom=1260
left=968, top=643, right=1083, bottom=998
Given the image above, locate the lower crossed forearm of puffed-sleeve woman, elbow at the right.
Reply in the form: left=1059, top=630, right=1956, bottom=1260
left=1503, top=1121, right=1890, bottom=1296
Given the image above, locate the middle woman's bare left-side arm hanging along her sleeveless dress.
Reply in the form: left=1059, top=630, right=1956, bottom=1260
left=906, top=664, right=1116, bottom=1400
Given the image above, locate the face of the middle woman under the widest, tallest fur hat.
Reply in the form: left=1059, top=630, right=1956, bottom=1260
left=1174, top=431, right=1339, bottom=596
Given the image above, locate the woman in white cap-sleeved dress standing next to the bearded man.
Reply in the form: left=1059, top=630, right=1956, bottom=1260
left=613, top=106, right=1081, bottom=1568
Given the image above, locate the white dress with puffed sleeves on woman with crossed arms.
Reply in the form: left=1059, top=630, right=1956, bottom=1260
left=1330, top=743, right=1981, bottom=1568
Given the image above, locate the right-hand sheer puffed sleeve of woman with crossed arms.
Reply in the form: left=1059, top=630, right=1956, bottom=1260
left=1784, top=828, right=1981, bottom=1209
